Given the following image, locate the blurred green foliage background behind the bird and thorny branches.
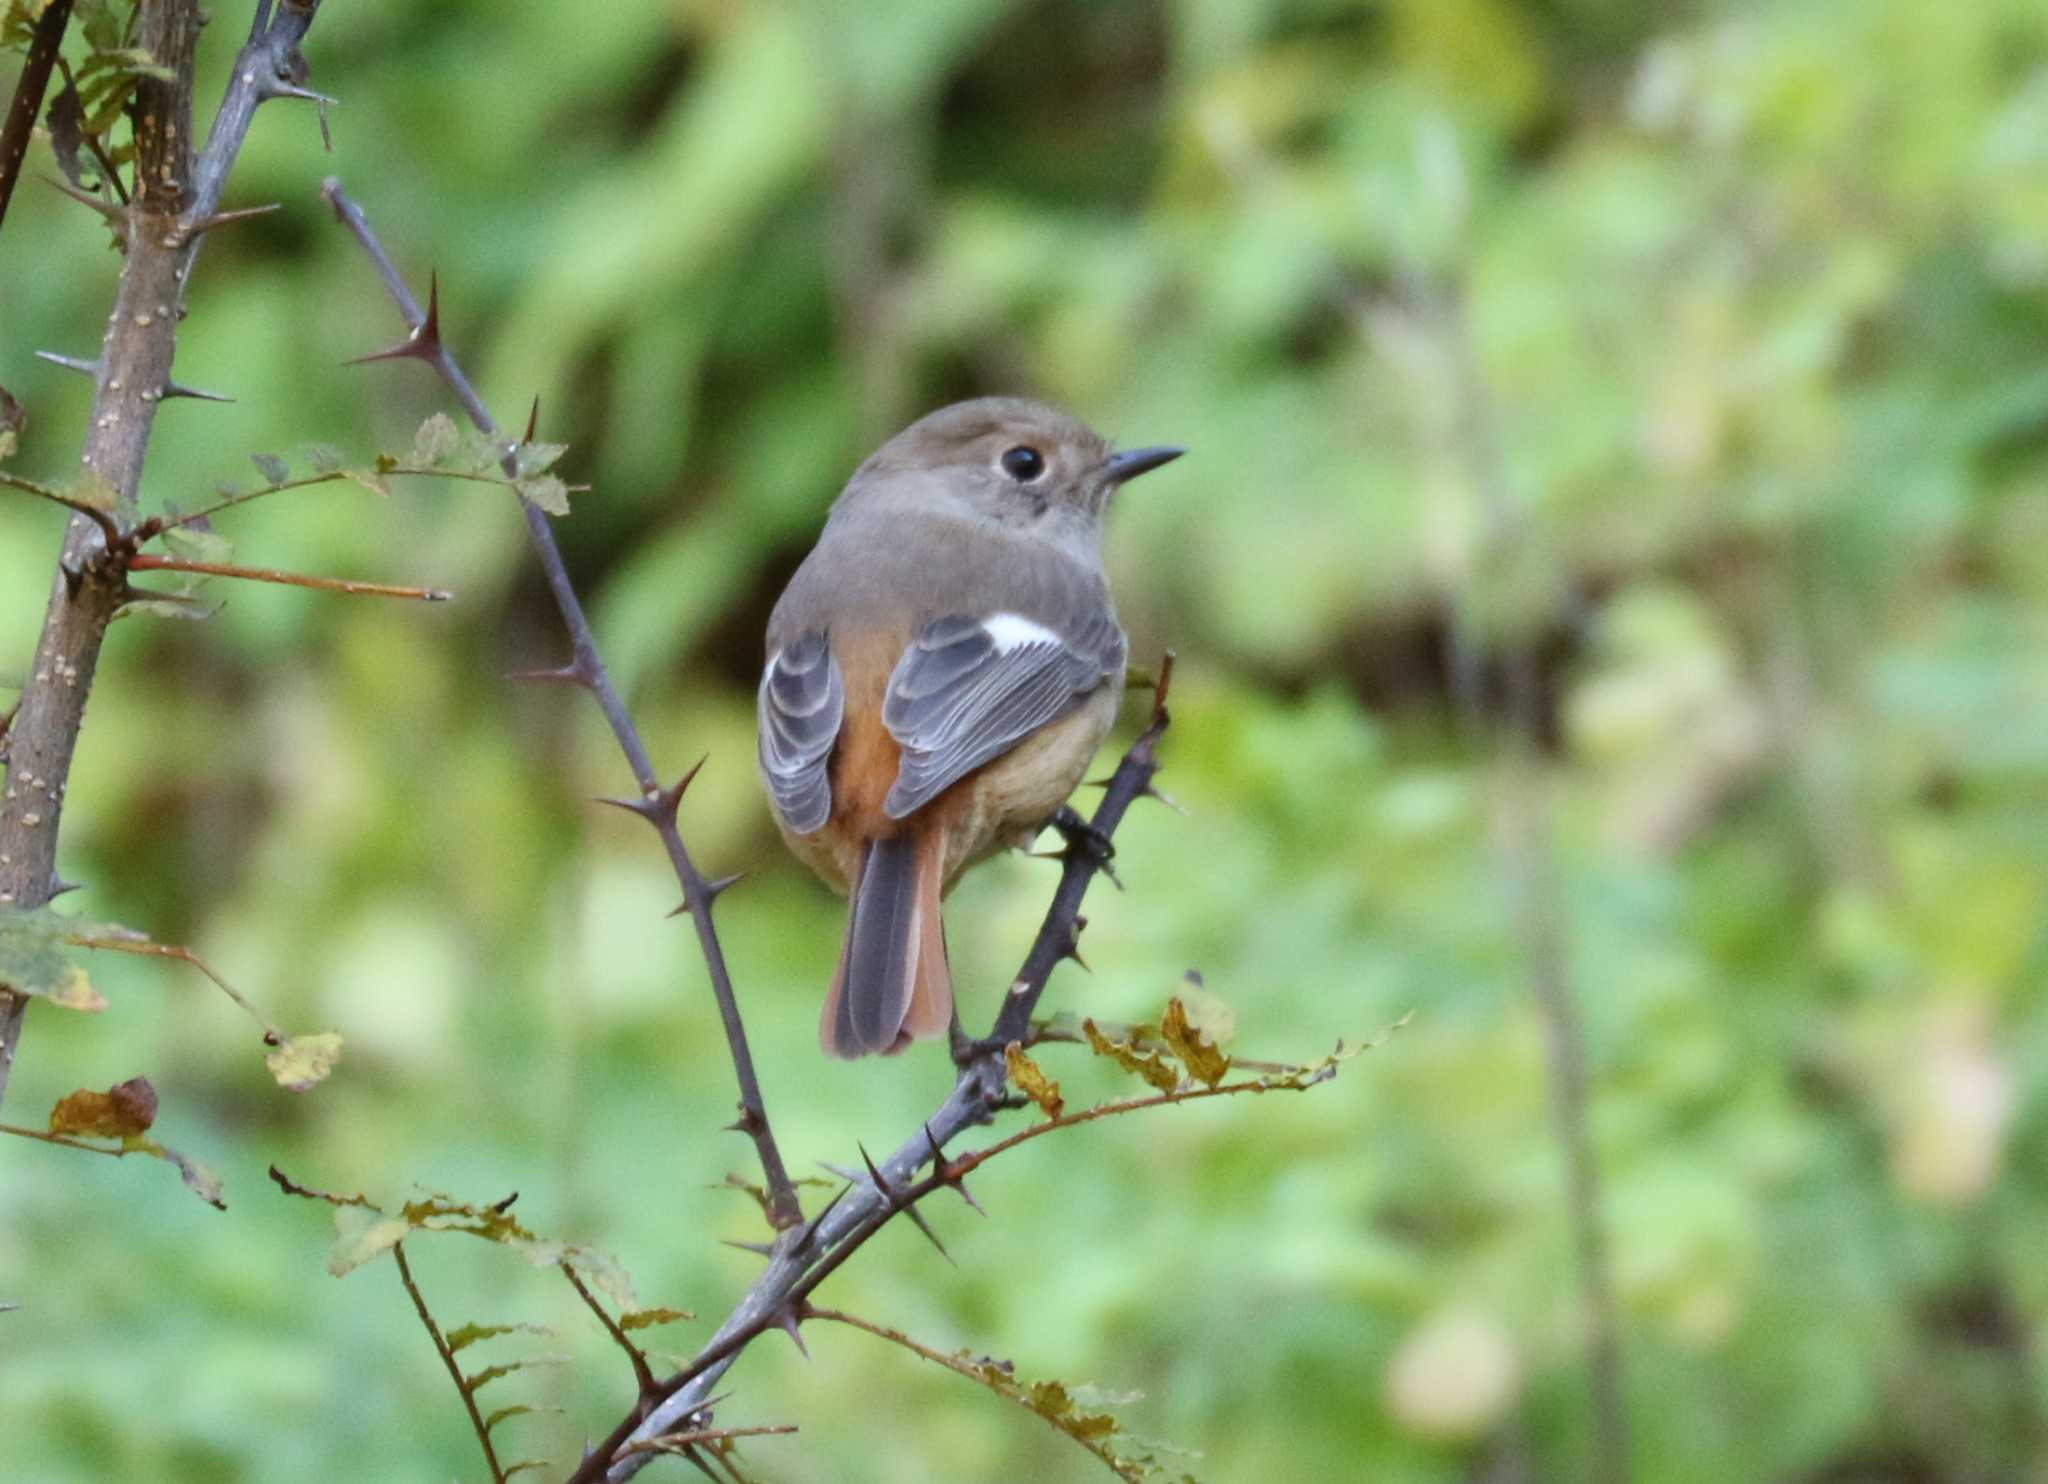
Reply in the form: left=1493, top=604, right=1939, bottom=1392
left=0, top=0, right=2048, bottom=1484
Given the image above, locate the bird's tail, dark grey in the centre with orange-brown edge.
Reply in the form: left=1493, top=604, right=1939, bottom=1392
left=817, top=827, right=952, bottom=1058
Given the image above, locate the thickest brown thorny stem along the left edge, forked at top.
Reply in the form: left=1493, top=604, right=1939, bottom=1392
left=0, top=0, right=319, bottom=1097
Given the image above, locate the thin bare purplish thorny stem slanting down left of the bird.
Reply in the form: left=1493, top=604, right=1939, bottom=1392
left=319, top=178, right=803, bottom=1232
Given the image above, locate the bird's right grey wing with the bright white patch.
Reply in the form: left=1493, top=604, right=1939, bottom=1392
left=883, top=600, right=1124, bottom=819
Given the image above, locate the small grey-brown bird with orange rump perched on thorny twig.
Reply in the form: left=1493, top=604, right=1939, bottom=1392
left=760, top=397, right=1182, bottom=1056
